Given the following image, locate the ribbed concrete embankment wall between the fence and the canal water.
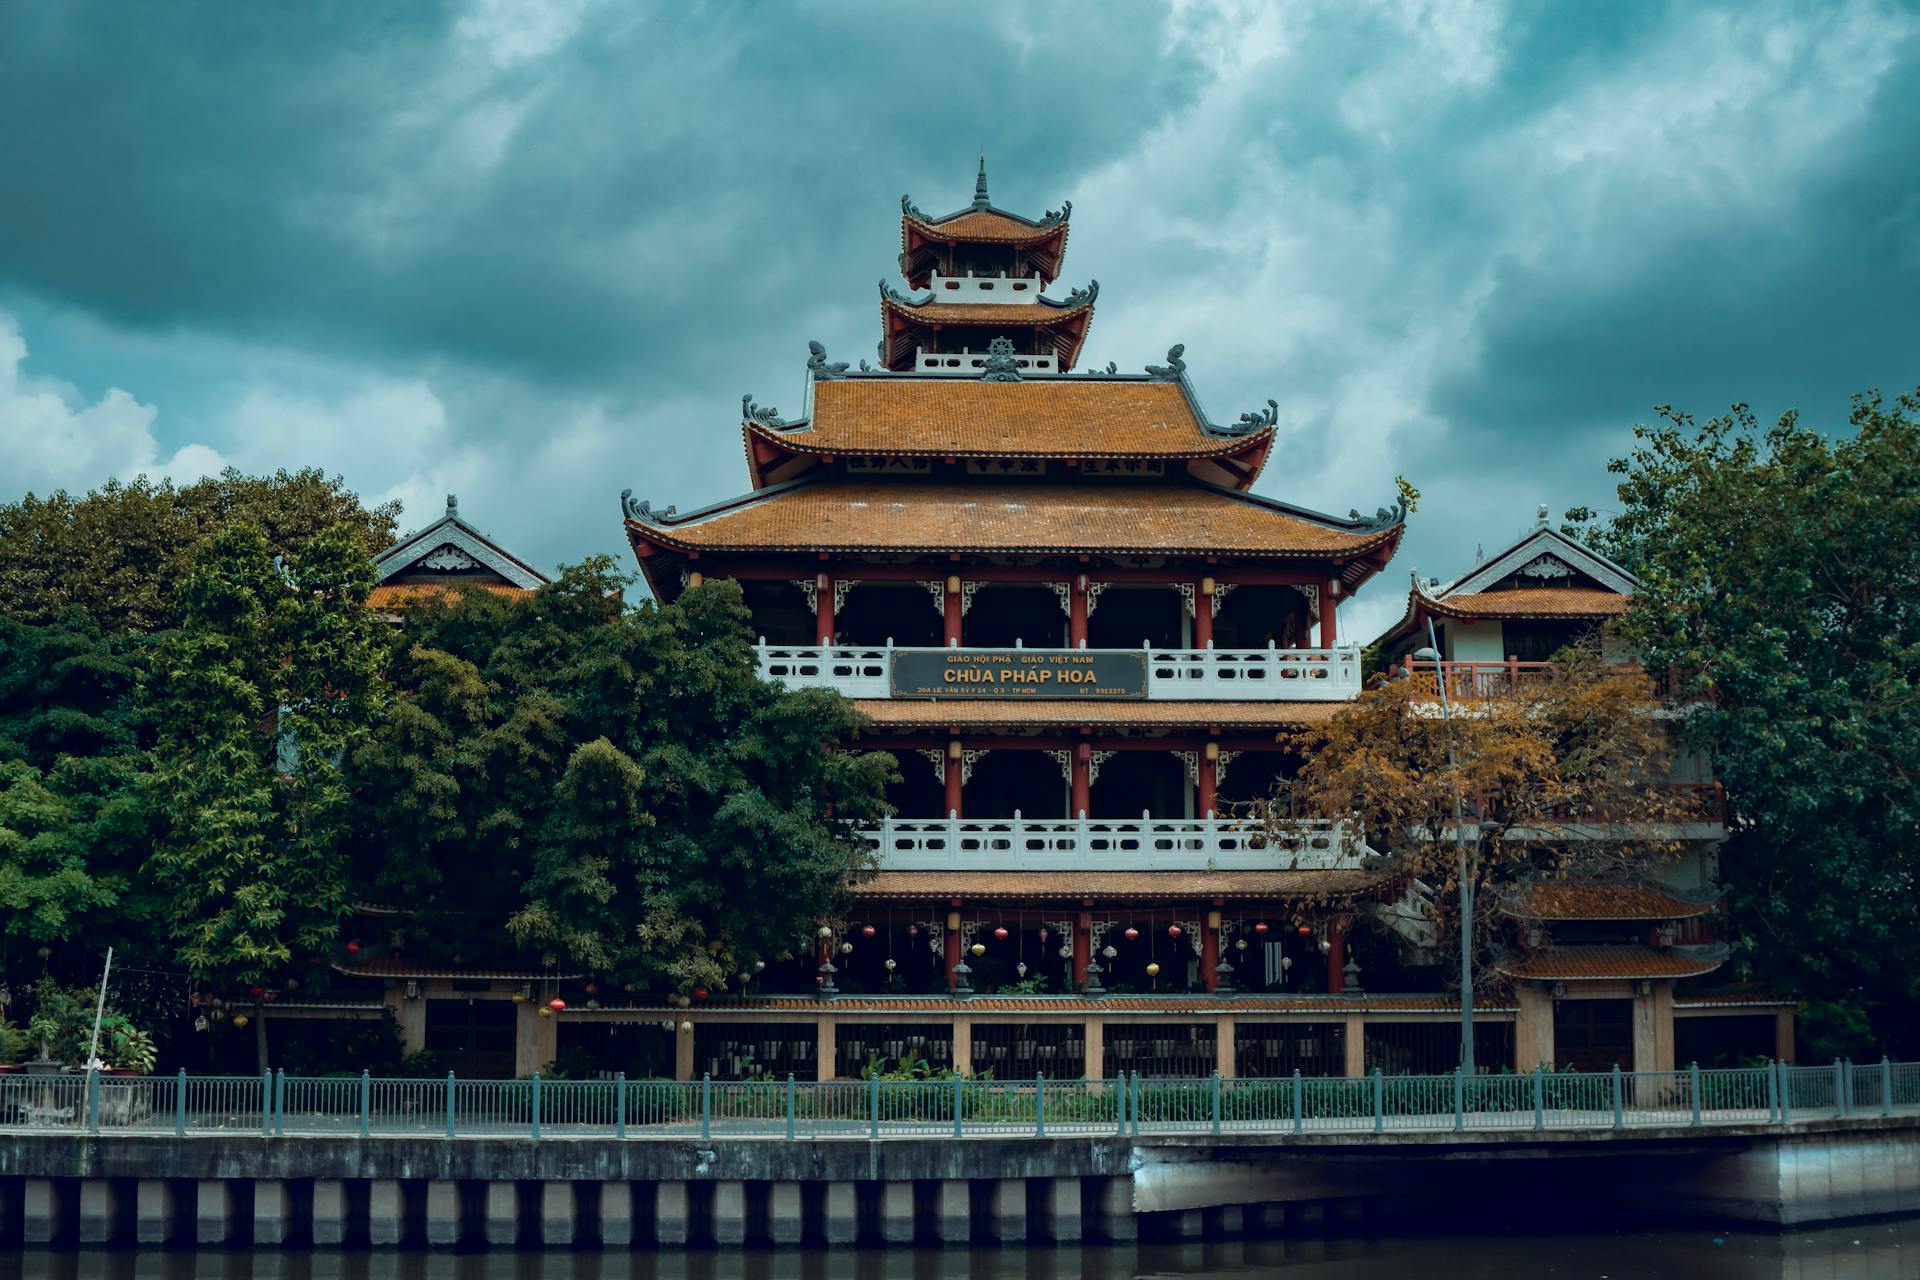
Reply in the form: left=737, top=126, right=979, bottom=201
left=0, top=1117, right=1920, bottom=1247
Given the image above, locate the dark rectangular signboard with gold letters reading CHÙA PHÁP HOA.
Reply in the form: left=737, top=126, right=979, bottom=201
left=887, top=649, right=1146, bottom=699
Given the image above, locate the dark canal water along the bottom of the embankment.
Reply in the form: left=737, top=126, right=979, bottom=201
left=0, top=1219, right=1920, bottom=1280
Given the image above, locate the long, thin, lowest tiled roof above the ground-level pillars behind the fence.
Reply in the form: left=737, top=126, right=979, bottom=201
left=566, top=994, right=1515, bottom=1021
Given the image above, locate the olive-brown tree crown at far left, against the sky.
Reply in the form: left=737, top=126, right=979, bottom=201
left=0, top=470, right=399, bottom=635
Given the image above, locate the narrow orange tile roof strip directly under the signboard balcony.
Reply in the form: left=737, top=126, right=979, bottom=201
left=852, top=699, right=1344, bottom=731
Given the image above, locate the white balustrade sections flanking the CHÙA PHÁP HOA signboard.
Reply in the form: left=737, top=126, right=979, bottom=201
left=755, top=643, right=1361, bottom=702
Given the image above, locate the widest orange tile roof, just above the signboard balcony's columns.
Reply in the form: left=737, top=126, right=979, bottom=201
left=628, top=480, right=1400, bottom=560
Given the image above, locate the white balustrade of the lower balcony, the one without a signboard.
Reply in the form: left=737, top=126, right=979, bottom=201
left=860, top=812, right=1373, bottom=871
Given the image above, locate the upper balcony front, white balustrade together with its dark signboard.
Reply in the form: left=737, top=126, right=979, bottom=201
left=755, top=643, right=1361, bottom=702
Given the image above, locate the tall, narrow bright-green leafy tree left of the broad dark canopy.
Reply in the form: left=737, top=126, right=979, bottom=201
left=148, top=526, right=390, bottom=1055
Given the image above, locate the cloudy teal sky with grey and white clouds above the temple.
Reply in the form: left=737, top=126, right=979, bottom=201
left=0, top=0, right=1920, bottom=639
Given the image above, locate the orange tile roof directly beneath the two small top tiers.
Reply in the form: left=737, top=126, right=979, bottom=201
left=749, top=376, right=1273, bottom=459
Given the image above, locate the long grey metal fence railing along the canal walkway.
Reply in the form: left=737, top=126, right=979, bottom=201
left=0, top=1059, right=1920, bottom=1140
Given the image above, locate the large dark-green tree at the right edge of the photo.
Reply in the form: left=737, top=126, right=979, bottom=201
left=1588, top=393, right=1920, bottom=1052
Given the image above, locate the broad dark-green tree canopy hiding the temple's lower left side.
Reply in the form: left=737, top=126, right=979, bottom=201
left=351, top=557, right=893, bottom=990
